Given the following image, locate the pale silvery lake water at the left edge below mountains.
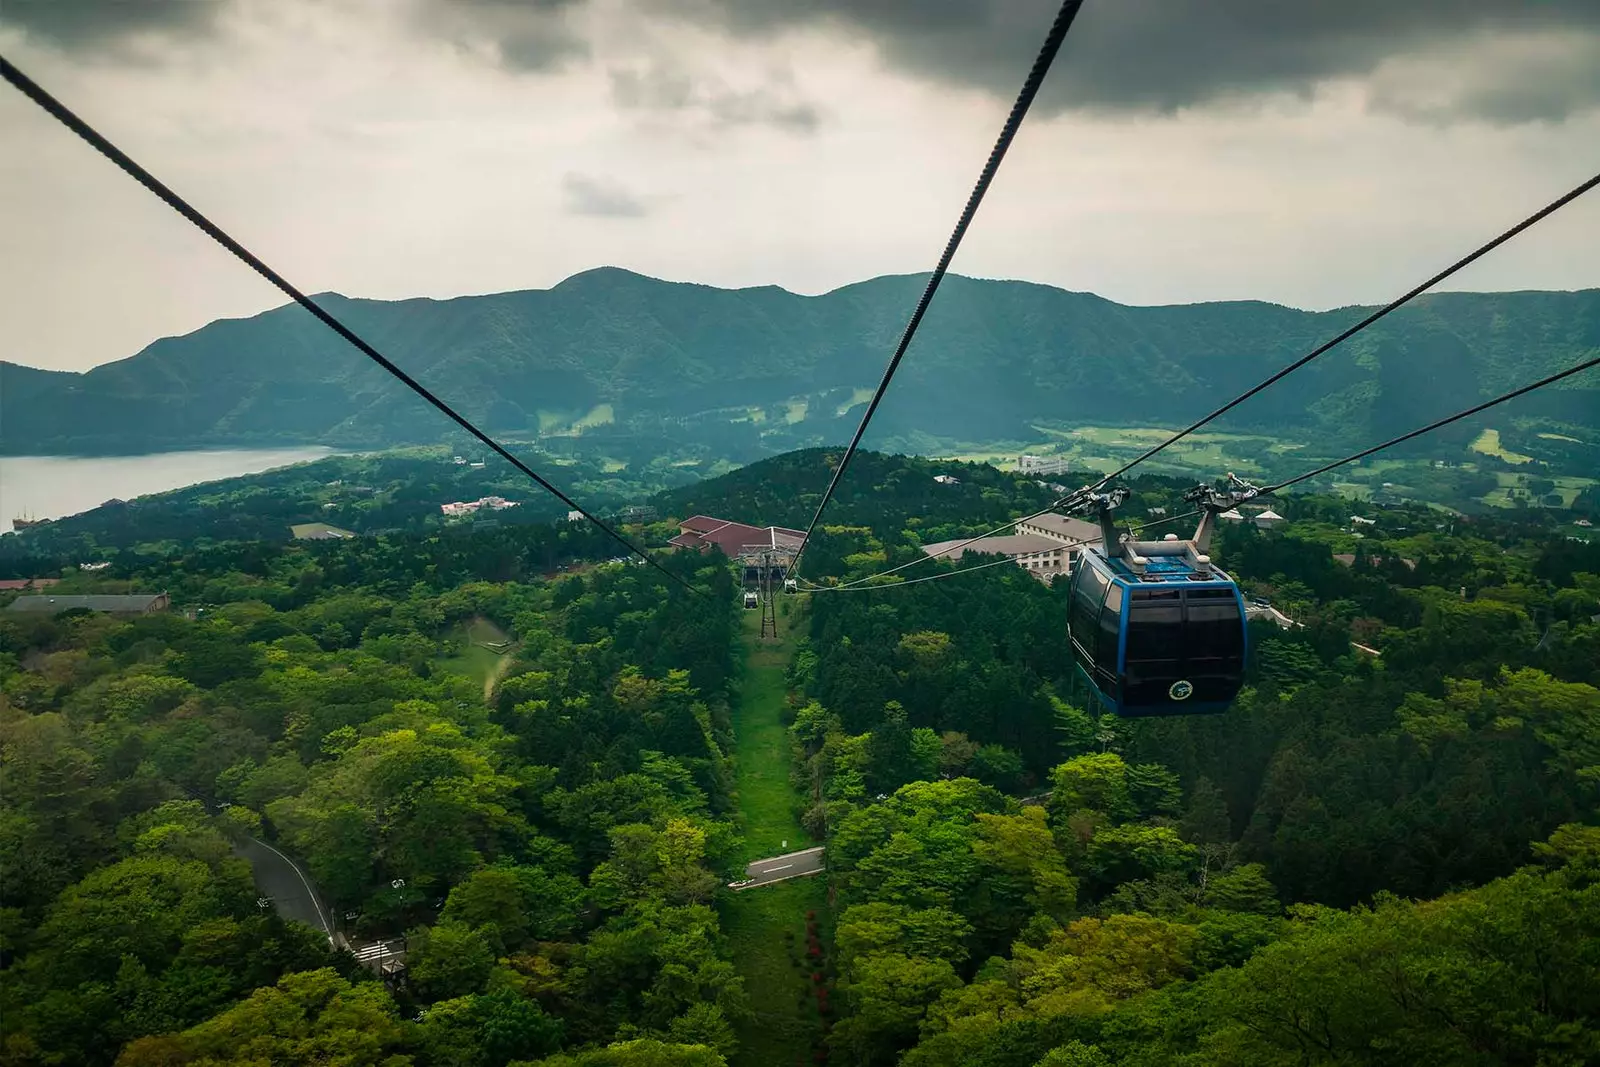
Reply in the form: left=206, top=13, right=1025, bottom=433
left=0, top=448, right=333, bottom=533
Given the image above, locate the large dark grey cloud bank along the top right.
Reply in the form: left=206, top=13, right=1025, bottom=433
left=643, top=0, right=1600, bottom=123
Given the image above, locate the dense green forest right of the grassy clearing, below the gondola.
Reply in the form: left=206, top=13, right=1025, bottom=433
left=792, top=482, right=1600, bottom=1067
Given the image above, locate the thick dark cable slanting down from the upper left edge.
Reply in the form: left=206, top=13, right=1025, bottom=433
left=0, top=56, right=706, bottom=597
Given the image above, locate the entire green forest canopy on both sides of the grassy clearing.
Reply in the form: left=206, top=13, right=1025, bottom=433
left=0, top=447, right=1600, bottom=1067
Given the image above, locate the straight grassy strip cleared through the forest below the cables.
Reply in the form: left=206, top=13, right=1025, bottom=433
left=722, top=611, right=827, bottom=1067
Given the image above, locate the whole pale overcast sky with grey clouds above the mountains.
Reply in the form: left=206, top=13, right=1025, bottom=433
left=0, top=0, right=1600, bottom=370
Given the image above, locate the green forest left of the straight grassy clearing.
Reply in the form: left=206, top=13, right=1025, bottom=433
left=0, top=526, right=744, bottom=1067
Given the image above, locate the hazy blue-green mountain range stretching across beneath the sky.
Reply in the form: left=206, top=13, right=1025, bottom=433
left=0, top=269, right=1600, bottom=461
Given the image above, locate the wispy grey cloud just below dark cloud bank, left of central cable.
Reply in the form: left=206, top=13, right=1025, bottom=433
left=611, top=61, right=819, bottom=133
